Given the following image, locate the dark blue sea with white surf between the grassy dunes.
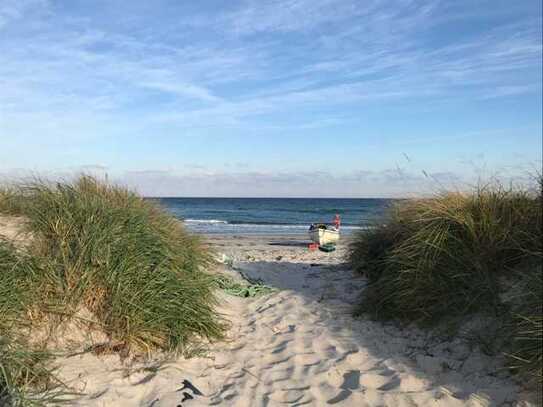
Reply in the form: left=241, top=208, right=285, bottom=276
left=156, top=198, right=392, bottom=235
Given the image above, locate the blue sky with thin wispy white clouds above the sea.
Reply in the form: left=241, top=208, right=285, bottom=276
left=0, top=0, right=543, bottom=197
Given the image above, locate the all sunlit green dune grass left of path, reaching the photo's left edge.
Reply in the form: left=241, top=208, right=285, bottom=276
left=0, top=176, right=224, bottom=404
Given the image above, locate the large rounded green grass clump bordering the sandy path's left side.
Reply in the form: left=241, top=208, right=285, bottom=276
left=13, top=177, right=223, bottom=352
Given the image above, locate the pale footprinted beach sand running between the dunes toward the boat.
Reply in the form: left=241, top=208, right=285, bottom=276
left=0, top=222, right=537, bottom=407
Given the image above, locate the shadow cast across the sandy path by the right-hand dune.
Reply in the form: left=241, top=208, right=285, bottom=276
left=234, top=262, right=531, bottom=406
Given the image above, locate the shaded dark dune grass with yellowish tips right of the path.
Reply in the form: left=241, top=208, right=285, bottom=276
left=349, top=182, right=543, bottom=382
